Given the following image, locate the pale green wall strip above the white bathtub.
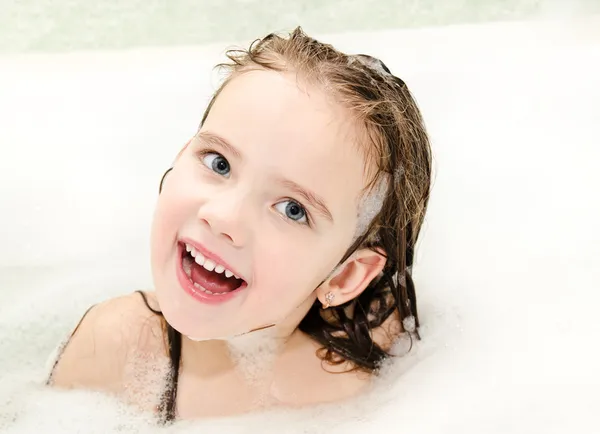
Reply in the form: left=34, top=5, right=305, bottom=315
left=0, top=0, right=600, bottom=53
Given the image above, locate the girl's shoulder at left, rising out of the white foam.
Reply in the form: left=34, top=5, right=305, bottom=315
left=51, top=293, right=166, bottom=393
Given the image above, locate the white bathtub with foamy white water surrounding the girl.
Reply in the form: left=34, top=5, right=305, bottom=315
left=0, top=17, right=600, bottom=434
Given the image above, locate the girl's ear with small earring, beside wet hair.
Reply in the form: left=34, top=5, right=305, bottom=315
left=317, top=249, right=387, bottom=306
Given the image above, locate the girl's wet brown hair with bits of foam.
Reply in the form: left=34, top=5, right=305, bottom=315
left=158, top=27, right=432, bottom=380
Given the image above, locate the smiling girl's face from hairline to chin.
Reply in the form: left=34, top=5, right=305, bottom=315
left=151, top=70, right=364, bottom=339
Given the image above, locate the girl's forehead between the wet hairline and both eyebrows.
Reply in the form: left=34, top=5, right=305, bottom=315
left=202, top=70, right=364, bottom=207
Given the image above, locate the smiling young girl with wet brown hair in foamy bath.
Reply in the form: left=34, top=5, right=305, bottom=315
left=48, top=28, right=431, bottom=421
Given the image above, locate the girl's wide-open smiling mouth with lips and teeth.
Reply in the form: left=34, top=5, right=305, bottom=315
left=176, top=242, right=248, bottom=304
